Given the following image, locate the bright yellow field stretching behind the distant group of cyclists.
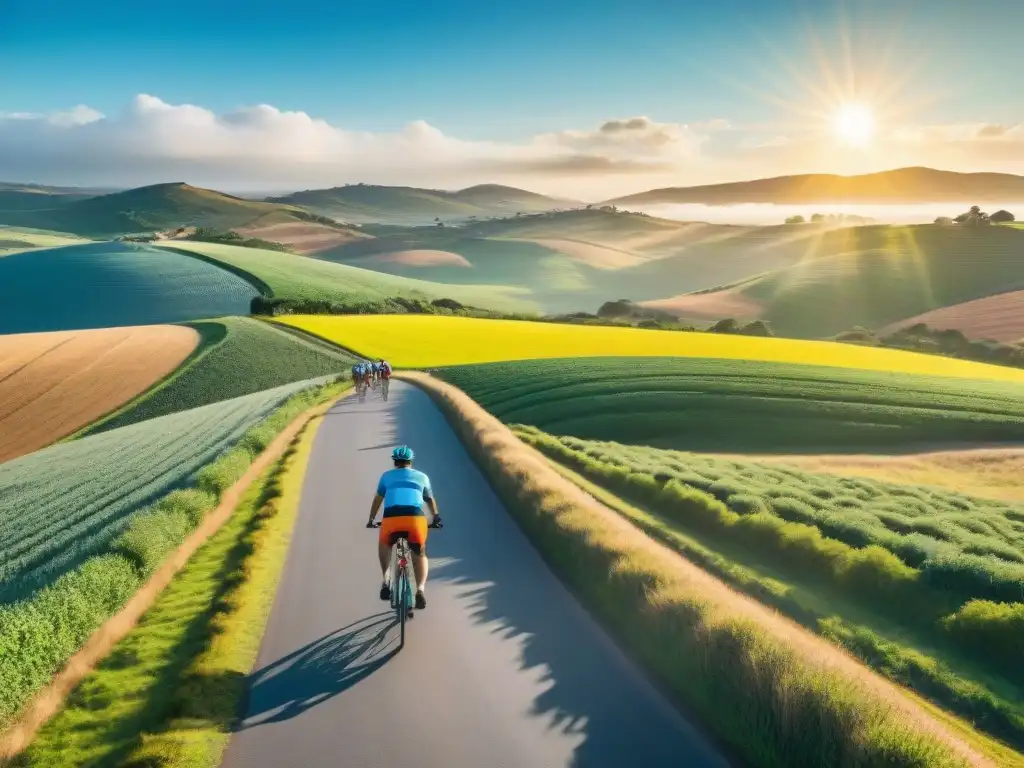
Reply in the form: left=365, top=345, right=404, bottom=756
left=278, top=314, right=1024, bottom=382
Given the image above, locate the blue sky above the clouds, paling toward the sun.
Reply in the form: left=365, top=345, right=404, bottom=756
left=0, top=0, right=1024, bottom=192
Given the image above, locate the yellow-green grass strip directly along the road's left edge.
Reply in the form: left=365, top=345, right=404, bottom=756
left=22, top=399, right=327, bottom=768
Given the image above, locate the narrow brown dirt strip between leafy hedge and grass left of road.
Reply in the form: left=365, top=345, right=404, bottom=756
left=0, top=393, right=345, bottom=766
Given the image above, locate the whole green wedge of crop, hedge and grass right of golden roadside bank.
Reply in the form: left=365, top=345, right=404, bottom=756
left=518, top=428, right=1024, bottom=749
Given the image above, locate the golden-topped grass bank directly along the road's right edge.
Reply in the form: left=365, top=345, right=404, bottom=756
left=403, top=375, right=994, bottom=768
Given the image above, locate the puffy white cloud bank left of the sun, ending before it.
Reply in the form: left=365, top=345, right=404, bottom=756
left=0, top=94, right=727, bottom=194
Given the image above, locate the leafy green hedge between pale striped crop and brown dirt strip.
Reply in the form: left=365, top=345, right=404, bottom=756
left=0, top=382, right=349, bottom=741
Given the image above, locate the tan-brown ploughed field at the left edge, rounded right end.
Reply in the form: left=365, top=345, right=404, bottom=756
left=0, top=326, right=200, bottom=462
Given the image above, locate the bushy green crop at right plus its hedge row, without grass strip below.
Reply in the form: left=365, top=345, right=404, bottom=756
left=517, top=427, right=1024, bottom=683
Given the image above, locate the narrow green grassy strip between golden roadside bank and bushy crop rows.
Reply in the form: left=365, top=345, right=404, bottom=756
left=540, top=459, right=1024, bottom=768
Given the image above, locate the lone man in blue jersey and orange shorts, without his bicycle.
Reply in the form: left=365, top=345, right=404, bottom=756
left=367, top=445, right=441, bottom=610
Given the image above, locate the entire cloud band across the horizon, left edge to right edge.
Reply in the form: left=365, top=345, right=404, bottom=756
left=0, top=94, right=1024, bottom=200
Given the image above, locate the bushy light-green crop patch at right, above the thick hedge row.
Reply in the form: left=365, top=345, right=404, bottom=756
left=527, top=435, right=1024, bottom=602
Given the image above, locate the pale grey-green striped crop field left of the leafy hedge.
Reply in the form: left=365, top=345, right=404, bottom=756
left=0, top=382, right=325, bottom=603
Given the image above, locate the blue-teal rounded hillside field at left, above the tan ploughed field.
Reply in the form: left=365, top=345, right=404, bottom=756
left=0, top=243, right=256, bottom=334
